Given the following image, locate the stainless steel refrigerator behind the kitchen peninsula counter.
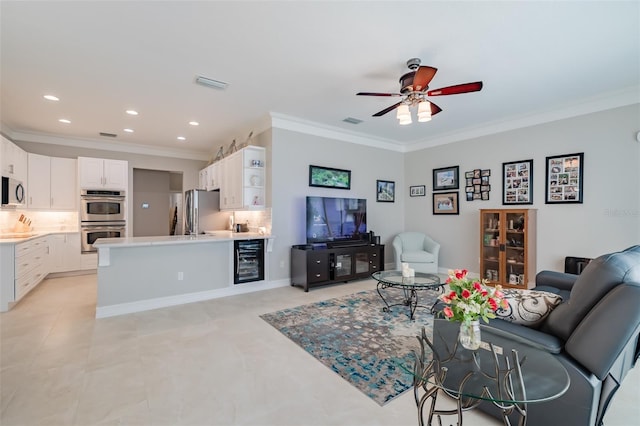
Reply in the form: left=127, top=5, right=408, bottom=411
left=184, top=189, right=222, bottom=235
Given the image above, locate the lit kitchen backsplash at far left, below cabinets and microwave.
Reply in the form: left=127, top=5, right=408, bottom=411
left=0, top=209, right=78, bottom=233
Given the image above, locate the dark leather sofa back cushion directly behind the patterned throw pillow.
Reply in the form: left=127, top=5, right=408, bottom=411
left=540, top=245, right=640, bottom=341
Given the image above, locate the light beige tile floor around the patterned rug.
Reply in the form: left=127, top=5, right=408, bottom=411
left=0, top=275, right=640, bottom=426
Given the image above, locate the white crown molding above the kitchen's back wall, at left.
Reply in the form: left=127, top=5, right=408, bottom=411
left=3, top=127, right=211, bottom=161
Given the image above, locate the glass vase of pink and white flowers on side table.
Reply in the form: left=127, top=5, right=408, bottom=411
left=440, top=269, right=507, bottom=350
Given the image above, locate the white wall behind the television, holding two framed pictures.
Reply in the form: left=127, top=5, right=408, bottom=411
left=270, top=128, right=406, bottom=280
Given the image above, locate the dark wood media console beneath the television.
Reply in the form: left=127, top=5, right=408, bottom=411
left=291, top=243, right=384, bottom=291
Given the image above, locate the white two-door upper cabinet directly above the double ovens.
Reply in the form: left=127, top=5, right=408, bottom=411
left=78, top=157, right=129, bottom=190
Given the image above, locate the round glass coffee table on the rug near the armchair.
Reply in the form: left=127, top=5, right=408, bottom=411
left=371, top=271, right=444, bottom=320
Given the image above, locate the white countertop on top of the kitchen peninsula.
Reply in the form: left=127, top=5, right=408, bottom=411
left=93, top=231, right=273, bottom=249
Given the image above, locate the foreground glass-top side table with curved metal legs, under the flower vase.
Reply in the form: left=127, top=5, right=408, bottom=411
left=402, top=319, right=570, bottom=426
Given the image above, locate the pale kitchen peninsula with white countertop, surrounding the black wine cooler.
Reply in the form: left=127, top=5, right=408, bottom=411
left=94, top=231, right=282, bottom=318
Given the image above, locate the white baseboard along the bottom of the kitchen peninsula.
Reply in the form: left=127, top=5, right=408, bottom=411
left=96, top=280, right=290, bottom=318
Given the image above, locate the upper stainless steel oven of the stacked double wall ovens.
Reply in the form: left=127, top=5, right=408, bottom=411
left=80, top=189, right=126, bottom=222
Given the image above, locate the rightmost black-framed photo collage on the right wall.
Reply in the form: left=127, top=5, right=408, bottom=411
left=545, top=152, right=584, bottom=204
